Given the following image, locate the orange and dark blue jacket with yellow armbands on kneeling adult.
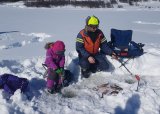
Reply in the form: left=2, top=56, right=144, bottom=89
left=76, top=29, right=112, bottom=58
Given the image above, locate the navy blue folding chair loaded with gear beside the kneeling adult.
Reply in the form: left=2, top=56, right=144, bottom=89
left=108, top=29, right=144, bottom=58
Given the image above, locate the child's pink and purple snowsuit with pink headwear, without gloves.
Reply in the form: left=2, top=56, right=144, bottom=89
left=45, top=41, right=65, bottom=89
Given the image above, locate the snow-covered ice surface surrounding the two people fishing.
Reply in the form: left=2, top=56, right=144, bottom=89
left=0, top=4, right=160, bottom=114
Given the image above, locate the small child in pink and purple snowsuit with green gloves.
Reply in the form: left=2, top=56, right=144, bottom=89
left=45, top=41, right=65, bottom=93
